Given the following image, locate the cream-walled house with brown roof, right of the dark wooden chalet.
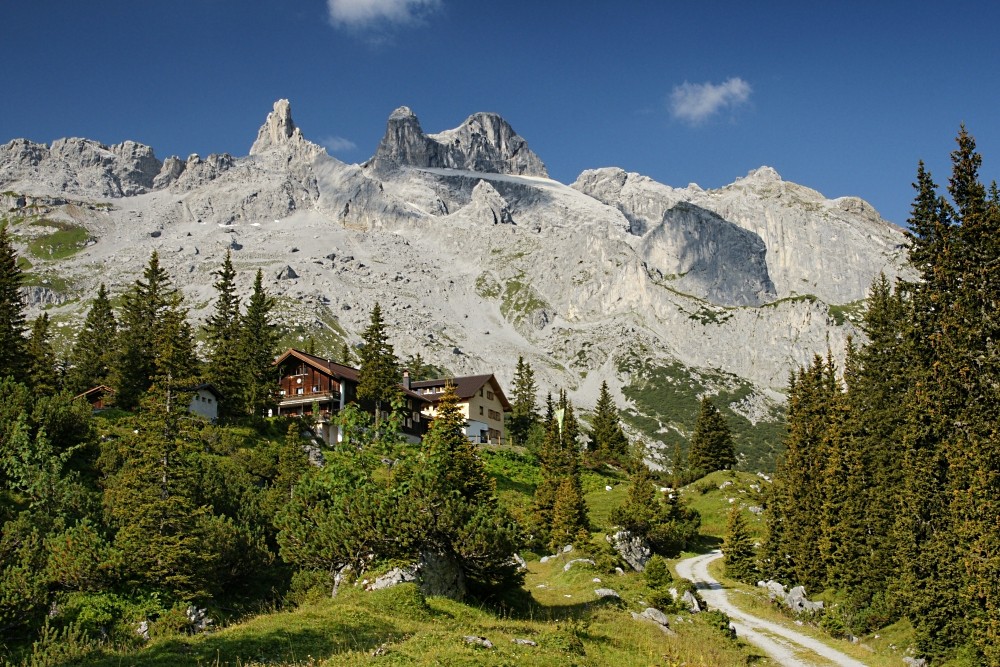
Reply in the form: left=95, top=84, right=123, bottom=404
left=403, top=374, right=511, bottom=445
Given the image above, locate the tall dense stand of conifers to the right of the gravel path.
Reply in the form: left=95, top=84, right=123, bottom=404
left=747, top=127, right=1000, bottom=665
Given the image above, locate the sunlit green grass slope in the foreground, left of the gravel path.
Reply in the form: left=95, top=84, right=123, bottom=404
left=60, top=449, right=762, bottom=667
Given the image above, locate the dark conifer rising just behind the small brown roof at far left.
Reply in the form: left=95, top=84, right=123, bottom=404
left=66, top=283, right=118, bottom=395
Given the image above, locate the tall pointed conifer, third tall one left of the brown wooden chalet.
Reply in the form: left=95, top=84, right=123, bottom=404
left=112, top=250, right=176, bottom=410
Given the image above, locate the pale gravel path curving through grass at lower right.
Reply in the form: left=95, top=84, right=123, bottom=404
left=677, top=551, right=866, bottom=667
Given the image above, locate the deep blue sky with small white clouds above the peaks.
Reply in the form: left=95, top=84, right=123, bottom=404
left=0, top=0, right=1000, bottom=224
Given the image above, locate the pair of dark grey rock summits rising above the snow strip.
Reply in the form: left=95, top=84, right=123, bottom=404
left=368, top=107, right=548, bottom=177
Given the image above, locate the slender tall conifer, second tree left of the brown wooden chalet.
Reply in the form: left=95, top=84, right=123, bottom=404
left=205, top=250, right=242, bottom=416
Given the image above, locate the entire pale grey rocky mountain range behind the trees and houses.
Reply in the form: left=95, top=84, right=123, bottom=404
left=0, top=100, right=907, bottom=464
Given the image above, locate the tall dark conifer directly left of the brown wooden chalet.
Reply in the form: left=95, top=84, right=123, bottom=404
left=236, top=269, right=279, bottom=417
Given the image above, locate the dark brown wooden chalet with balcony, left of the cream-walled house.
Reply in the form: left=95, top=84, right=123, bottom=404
left=274, top=348, right=429, bottom=444
